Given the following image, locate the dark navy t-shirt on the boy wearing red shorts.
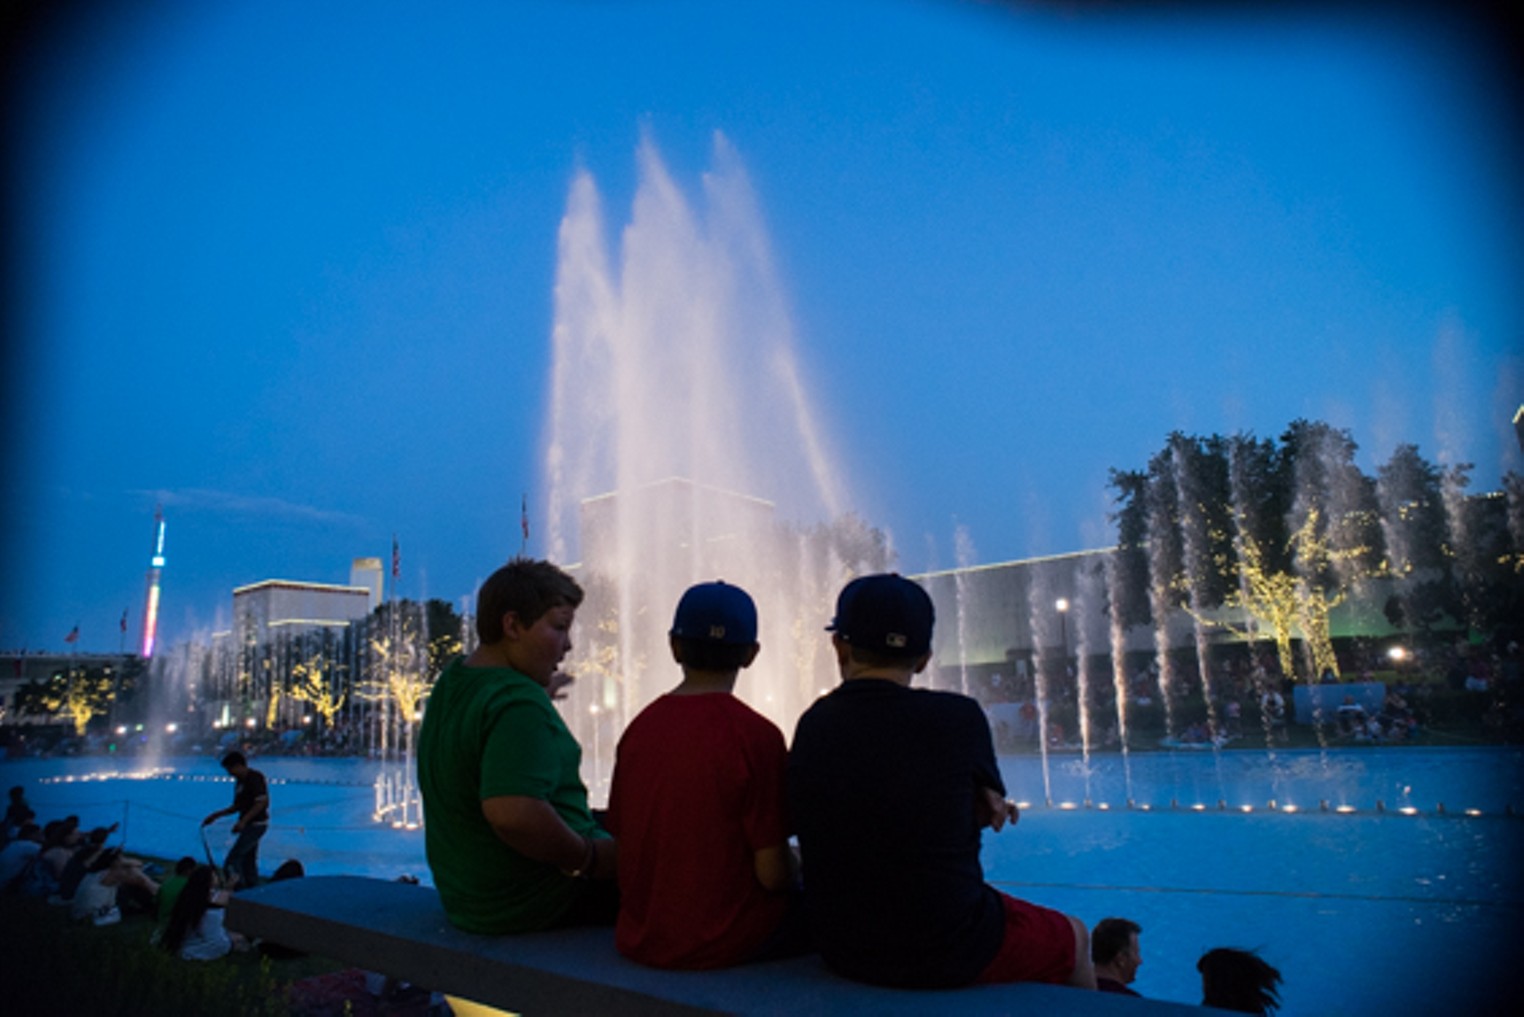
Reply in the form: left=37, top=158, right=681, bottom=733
left=788, top=679, right=1006, bottom=988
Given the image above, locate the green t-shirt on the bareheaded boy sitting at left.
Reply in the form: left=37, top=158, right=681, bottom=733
left=418, top=657, right=607, bottom=933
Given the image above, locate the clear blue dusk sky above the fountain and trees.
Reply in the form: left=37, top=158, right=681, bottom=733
left=0, top=0, right=1524, bottom=651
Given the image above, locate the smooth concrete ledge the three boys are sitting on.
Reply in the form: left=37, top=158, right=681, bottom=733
left=227, top=875, right=1210, bottom=1017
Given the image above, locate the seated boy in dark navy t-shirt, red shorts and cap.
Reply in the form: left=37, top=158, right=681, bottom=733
left=788, top=575, right=1096, bottom=988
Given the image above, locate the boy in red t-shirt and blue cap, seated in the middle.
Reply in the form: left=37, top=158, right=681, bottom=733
left=608, top=582, right=792, bottom=968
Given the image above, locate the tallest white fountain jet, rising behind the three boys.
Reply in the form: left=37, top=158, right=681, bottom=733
left=546, top=136, right=888, bottom=799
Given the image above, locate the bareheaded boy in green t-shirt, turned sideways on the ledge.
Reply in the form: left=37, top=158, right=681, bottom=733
left=418, top=558, right=619, bottom=935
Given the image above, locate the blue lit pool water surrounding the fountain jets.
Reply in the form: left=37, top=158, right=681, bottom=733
left=0, top=747, right=1524, bottom=1014
